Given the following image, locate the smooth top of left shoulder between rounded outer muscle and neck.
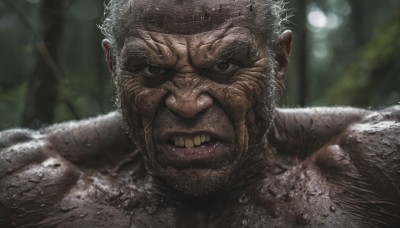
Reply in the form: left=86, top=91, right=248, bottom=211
left=42, top=112, right=135, bottom=167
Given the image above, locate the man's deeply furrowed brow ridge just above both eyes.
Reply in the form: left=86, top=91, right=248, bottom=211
left=121, top=28, right=266, bottom=80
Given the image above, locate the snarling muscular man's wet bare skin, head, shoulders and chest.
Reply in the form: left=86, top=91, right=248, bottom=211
left=0, top=1, right=400, bottom=227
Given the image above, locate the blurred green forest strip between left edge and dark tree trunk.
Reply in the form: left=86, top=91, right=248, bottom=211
left=0, top=0, right=38, bottom=129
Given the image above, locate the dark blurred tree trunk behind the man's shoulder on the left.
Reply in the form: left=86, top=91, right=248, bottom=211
left=22, top=0, right=66, bottom=128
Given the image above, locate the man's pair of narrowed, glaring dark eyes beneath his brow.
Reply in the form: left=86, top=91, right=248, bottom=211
left=141, top=61, right=240, bottom=78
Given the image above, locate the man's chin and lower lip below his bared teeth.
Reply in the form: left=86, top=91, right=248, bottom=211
left=146, top=135, right=243, bottom=196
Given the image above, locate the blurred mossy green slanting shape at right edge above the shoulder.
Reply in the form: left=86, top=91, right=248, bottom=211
left=329, top=8, right=400, bottom=107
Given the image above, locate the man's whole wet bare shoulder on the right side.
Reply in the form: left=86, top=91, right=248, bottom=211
left=268, top=106, right=400, bottom=227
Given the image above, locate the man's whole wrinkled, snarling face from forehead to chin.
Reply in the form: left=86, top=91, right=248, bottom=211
left=104, top=0, right=290, bottom=195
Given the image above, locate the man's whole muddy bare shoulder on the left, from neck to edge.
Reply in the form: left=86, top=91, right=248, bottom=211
left=0, top=113, right=139, bottom=227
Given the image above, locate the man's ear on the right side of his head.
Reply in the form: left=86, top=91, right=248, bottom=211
left=275, top=30, right=293, bottom=83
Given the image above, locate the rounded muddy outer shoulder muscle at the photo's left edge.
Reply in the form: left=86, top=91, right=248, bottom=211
left=0, top=129, right=79, bottom=227
